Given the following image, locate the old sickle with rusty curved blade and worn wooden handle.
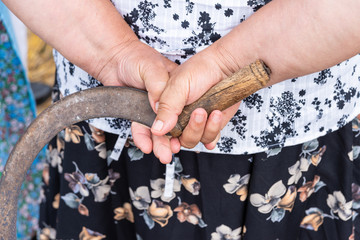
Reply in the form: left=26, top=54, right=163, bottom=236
left=0, top=60, right=270, bottom=240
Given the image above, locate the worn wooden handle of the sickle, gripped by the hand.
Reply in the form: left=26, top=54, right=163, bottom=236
left=170, top=60, right=270, bottom=137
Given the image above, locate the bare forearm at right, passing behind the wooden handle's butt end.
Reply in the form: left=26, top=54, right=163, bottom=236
left=212, top=0, right=360, bottom=85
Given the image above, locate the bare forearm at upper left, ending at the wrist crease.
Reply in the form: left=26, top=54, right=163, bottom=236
left=3, top=0, right=137, bottom=80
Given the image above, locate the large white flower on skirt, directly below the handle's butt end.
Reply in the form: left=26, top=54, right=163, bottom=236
left=250, top=180, right=286, bottom=214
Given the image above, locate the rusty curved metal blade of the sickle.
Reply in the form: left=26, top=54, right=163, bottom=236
left=0, top=87, right=155, bottom=240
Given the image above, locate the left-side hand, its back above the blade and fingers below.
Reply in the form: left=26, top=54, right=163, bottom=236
left=97, top=40, right=181, bottom=158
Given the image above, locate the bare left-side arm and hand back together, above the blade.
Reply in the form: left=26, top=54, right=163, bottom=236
left=3, top=0, right=176, bottom=109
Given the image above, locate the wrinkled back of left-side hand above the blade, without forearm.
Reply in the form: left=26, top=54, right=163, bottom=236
left=97, top=39, right=177, bottom=111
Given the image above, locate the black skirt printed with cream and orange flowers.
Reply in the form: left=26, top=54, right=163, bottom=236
left=39, top=119, right=360, bottom=240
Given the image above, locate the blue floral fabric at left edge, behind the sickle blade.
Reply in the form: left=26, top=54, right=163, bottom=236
left=0, top=1, right=44, bottom=239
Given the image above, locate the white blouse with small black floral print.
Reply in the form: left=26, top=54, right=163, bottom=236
left=54, top=0, right=360, bottom=157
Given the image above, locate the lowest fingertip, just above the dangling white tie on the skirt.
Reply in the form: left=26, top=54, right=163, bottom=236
left=152, top=135, right=172, bottom=164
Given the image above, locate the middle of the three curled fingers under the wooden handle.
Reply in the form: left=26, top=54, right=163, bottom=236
left=200, top=110, right=223, bottom=144
